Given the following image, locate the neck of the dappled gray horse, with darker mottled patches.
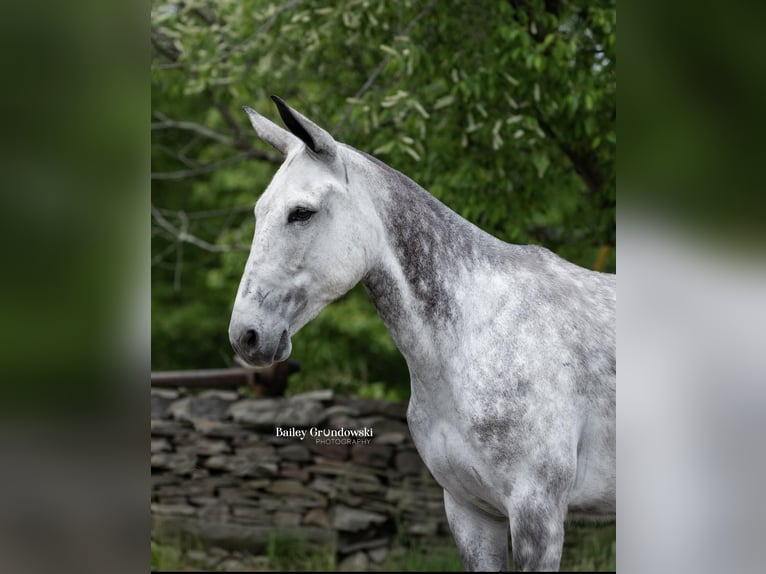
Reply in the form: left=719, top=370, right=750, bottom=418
left=354, top=148, right=497, bottom=374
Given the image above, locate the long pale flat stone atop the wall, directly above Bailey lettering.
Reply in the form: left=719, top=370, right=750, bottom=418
left=228, top=399, right=322, bottom=432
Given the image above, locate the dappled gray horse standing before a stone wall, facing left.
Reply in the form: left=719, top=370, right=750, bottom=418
left=229, top=97, right=616, bottom=570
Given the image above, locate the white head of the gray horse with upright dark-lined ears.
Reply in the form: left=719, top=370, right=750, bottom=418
left=229, top=96, right=379, bottom=366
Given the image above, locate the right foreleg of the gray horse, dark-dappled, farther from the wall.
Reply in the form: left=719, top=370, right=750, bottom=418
left=509, top=497, right=566, bottom=572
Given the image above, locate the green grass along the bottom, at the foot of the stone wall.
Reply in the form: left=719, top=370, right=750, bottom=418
left=151, top=522, right=617, bottom=572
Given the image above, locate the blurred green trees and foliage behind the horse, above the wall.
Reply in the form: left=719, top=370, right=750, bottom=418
left=151, top=0, right=617, bottom=399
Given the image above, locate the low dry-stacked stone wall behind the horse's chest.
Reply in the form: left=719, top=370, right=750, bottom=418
left=151, top=389, right=450, bottom=569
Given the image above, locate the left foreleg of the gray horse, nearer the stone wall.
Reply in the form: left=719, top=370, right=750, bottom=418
left=444, top=490, right=508, bottom=572
